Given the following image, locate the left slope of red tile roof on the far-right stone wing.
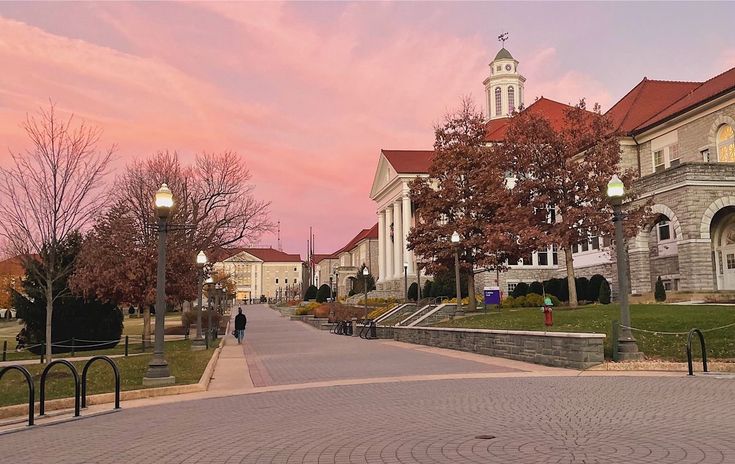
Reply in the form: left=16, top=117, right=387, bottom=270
left=606, top=77, right=701, bottom=133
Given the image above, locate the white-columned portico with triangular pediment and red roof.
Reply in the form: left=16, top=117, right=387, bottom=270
left=370, top=150, right=432, bottom=297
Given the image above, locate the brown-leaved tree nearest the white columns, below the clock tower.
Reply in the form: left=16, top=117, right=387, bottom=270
left=408, top=99, right=524, bottom=311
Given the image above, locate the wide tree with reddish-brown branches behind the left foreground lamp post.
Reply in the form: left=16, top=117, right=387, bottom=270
left=71, top=152, right=273, bottom=342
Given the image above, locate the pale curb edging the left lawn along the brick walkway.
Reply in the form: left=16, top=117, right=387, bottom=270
left=0, top=330, right=229, bottom=419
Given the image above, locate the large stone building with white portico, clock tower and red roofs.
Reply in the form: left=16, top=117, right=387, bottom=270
left=370, top=48, right=735, bottom=294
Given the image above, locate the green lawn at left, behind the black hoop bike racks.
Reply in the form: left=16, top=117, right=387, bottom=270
left=0, top=340, right=217, bottom=406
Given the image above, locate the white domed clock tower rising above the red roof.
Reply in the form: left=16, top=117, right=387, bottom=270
left=482, top=45, right=526, bottom=119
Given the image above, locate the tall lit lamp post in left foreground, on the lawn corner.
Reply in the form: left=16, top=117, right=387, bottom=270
left=143, top=184, right=176, bottom=386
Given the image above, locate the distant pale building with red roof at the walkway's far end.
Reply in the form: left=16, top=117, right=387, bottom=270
left=210, top=248, right=304, bottom=301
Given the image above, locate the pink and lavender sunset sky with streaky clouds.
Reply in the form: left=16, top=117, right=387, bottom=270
left=0, top=2, right=735, bottom=256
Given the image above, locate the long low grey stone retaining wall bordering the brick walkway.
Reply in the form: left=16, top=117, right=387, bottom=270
left=388, top=327, right=605, bottom=369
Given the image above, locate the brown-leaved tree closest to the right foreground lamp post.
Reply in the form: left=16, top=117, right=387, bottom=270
left=493, top=100, right=645, bottom=306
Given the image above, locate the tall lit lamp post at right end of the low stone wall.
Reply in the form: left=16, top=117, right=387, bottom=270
left=607, top=174, right=643, bottom=360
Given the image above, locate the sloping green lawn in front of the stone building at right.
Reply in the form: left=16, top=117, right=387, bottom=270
left=437, top=304, right=735, bottom=361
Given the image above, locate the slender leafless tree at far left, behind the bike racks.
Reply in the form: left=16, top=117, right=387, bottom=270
left=0, top=103, right=115, bottom=360
